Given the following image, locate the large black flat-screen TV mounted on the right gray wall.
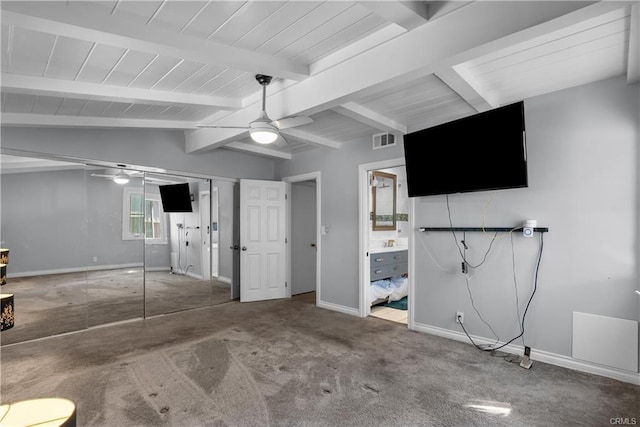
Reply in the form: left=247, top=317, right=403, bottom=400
left=404, top=101, right=528, bottom=197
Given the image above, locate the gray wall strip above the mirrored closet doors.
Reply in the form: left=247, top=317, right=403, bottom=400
left=2, top=127, right=274, bottom=179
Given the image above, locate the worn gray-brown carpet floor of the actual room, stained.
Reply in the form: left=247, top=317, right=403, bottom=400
left=0, top=297, right=640, bottom=426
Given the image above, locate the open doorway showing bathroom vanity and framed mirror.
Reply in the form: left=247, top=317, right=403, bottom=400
left=359, top=159, right=413, bottom=327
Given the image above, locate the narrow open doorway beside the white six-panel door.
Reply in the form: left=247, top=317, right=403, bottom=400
left=283, top=172, right=320, bottom=305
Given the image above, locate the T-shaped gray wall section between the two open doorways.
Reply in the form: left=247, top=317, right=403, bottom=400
left=276, top=131, right=404, bottom=308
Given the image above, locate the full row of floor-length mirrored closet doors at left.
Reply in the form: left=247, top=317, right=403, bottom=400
left=0, top=154, right=233, bottom=345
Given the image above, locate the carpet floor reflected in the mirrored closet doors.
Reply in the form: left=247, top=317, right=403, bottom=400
left=2, top=268, right=231, bottom=345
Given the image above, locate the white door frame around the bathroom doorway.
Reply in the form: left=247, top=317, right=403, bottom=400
left=358, top=157, right=415, bottom=329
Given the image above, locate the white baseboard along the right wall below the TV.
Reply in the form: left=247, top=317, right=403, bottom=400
left=413, top=322, right=640, bottom=385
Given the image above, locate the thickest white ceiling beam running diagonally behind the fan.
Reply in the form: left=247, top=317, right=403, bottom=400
left=186, top=2, right=596, bottom=152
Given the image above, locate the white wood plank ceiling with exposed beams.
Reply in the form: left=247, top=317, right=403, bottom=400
left=0, top=0, right=640, bottom=159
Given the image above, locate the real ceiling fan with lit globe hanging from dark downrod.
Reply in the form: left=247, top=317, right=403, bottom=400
left=198, top=74, right=313, bottom=145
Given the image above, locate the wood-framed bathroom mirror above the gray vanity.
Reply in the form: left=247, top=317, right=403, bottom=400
left=371, top=171, right=397, bottom=231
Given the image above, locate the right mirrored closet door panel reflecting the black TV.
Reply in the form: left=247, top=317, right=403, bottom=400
left=143, top=173, right=211, bottom=316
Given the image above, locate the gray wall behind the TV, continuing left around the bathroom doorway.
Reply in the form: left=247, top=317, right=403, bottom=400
left=276, top=78, right=640, bottom=362
